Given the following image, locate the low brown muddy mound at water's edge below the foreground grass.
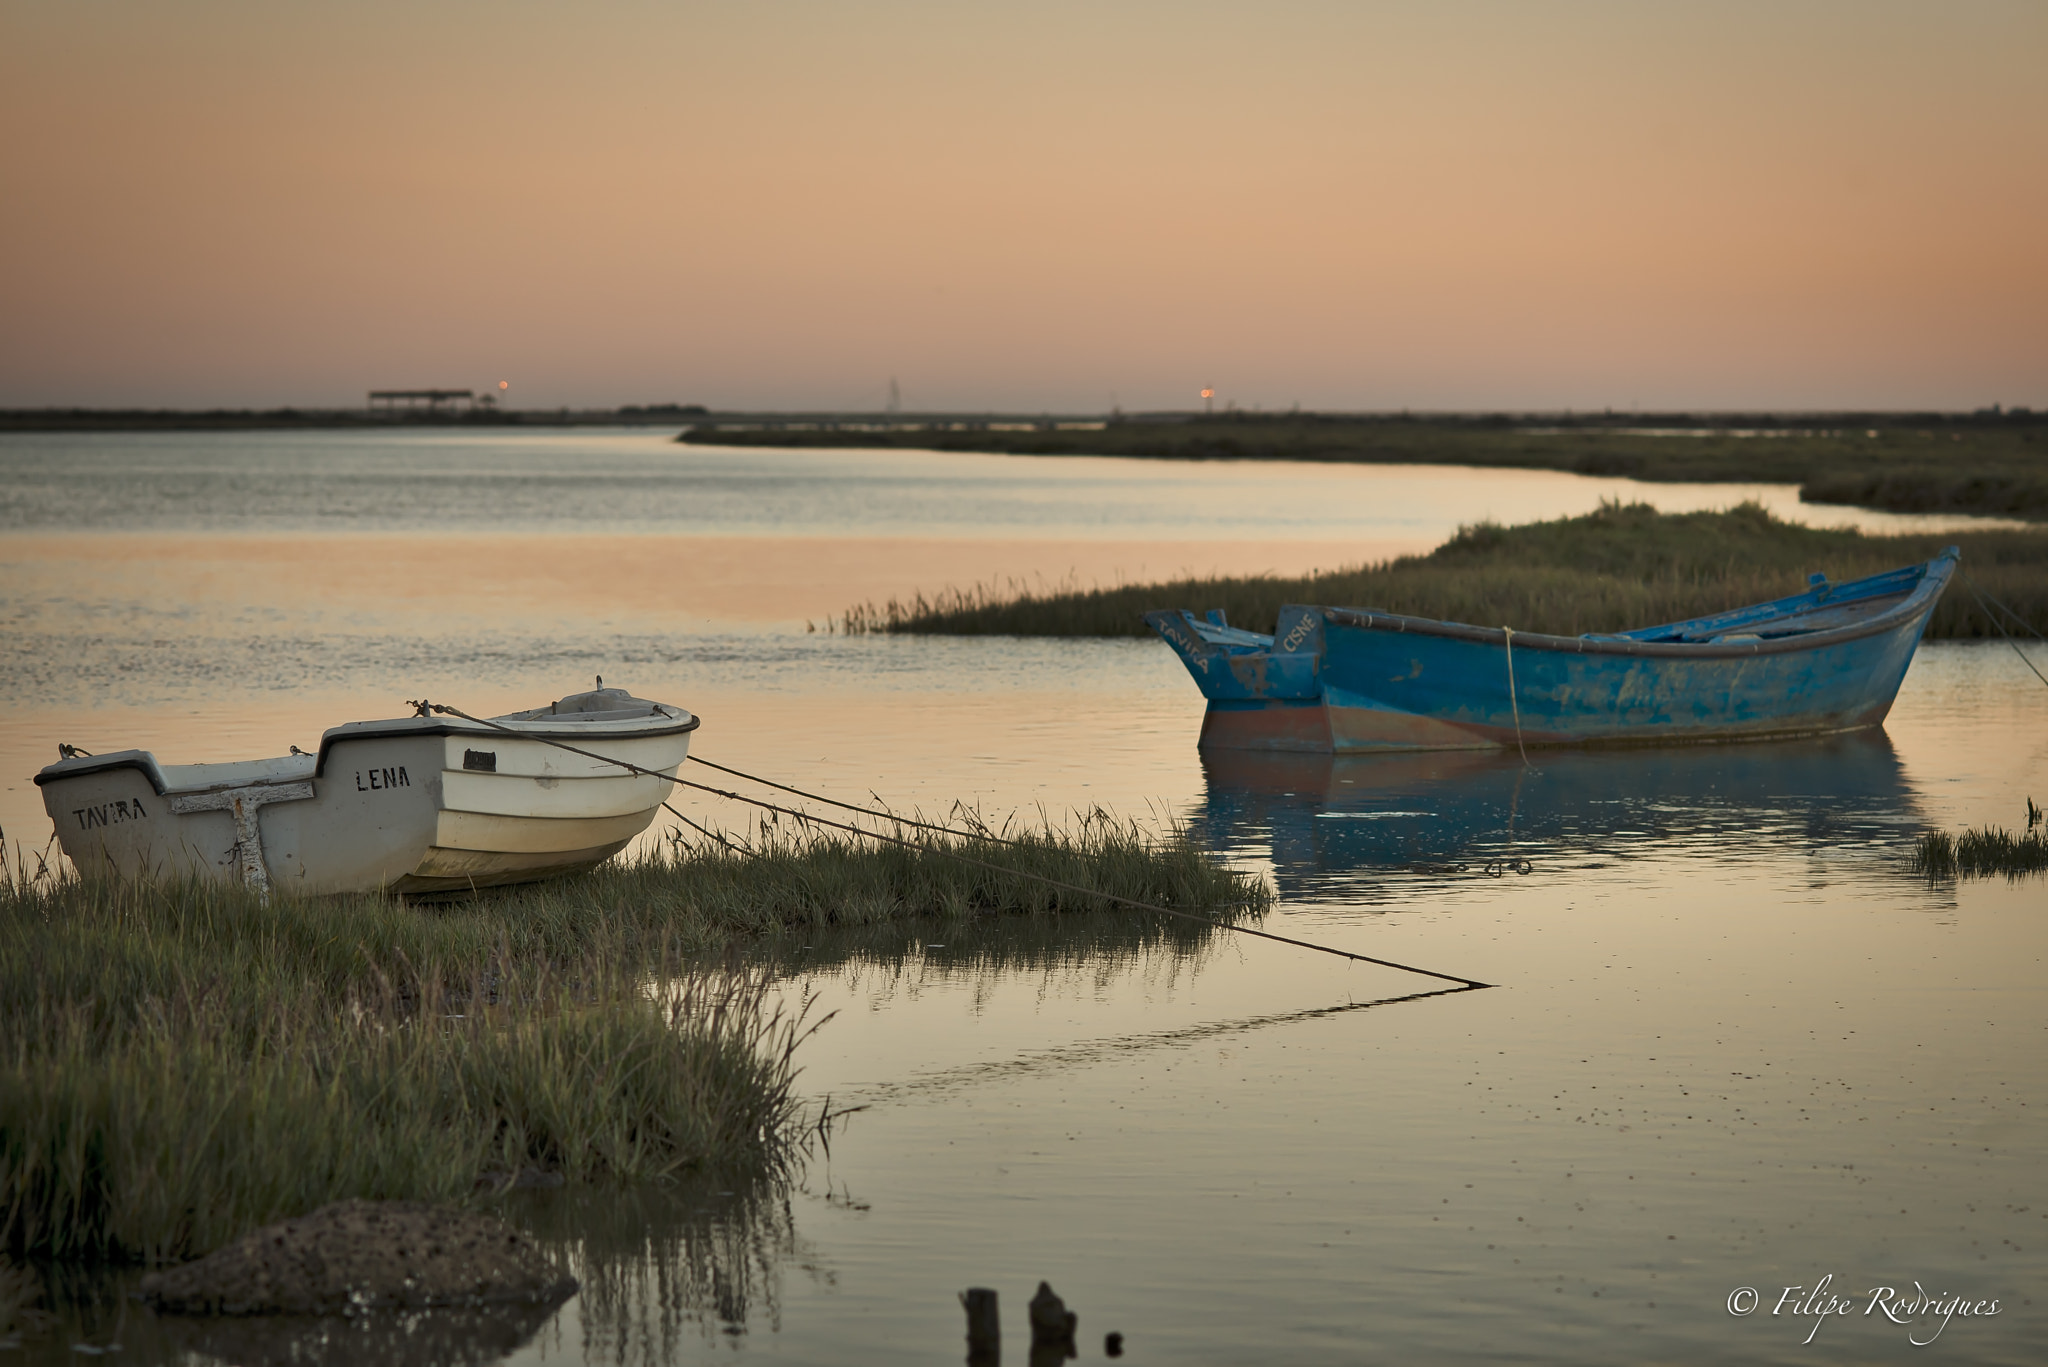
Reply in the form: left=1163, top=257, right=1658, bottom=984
left=141, top=1201, right=575, bottom=1316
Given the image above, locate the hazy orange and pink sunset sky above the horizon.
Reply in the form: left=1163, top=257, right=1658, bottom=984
left=0, top=0, right=2048, bottom=412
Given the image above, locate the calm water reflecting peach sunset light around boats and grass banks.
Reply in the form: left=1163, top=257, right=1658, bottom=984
left=0, top=432, right=2048, bottom=1363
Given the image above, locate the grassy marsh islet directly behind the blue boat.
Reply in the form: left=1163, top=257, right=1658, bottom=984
left=836, top=504, right=2048, bottom=639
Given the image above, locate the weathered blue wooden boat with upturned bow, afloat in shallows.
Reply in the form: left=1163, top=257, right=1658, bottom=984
left=1145, top=545, right=1960, bottom=754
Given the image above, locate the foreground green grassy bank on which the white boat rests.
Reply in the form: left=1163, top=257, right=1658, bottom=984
left=0, top=820, right=1266, bottom=1260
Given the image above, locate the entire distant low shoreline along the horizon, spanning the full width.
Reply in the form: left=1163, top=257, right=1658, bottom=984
left=16, top=404, right=2048, bottom=521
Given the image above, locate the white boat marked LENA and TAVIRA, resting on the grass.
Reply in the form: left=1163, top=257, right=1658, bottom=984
left=35, top=680, right=698, bottom=894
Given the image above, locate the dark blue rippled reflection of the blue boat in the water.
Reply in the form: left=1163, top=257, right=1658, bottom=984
left=1190, top=730, right=1921, bottom=902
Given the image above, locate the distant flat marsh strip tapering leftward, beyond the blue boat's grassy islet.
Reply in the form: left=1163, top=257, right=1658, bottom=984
left=678, top=412, right=2048, bottom=519
